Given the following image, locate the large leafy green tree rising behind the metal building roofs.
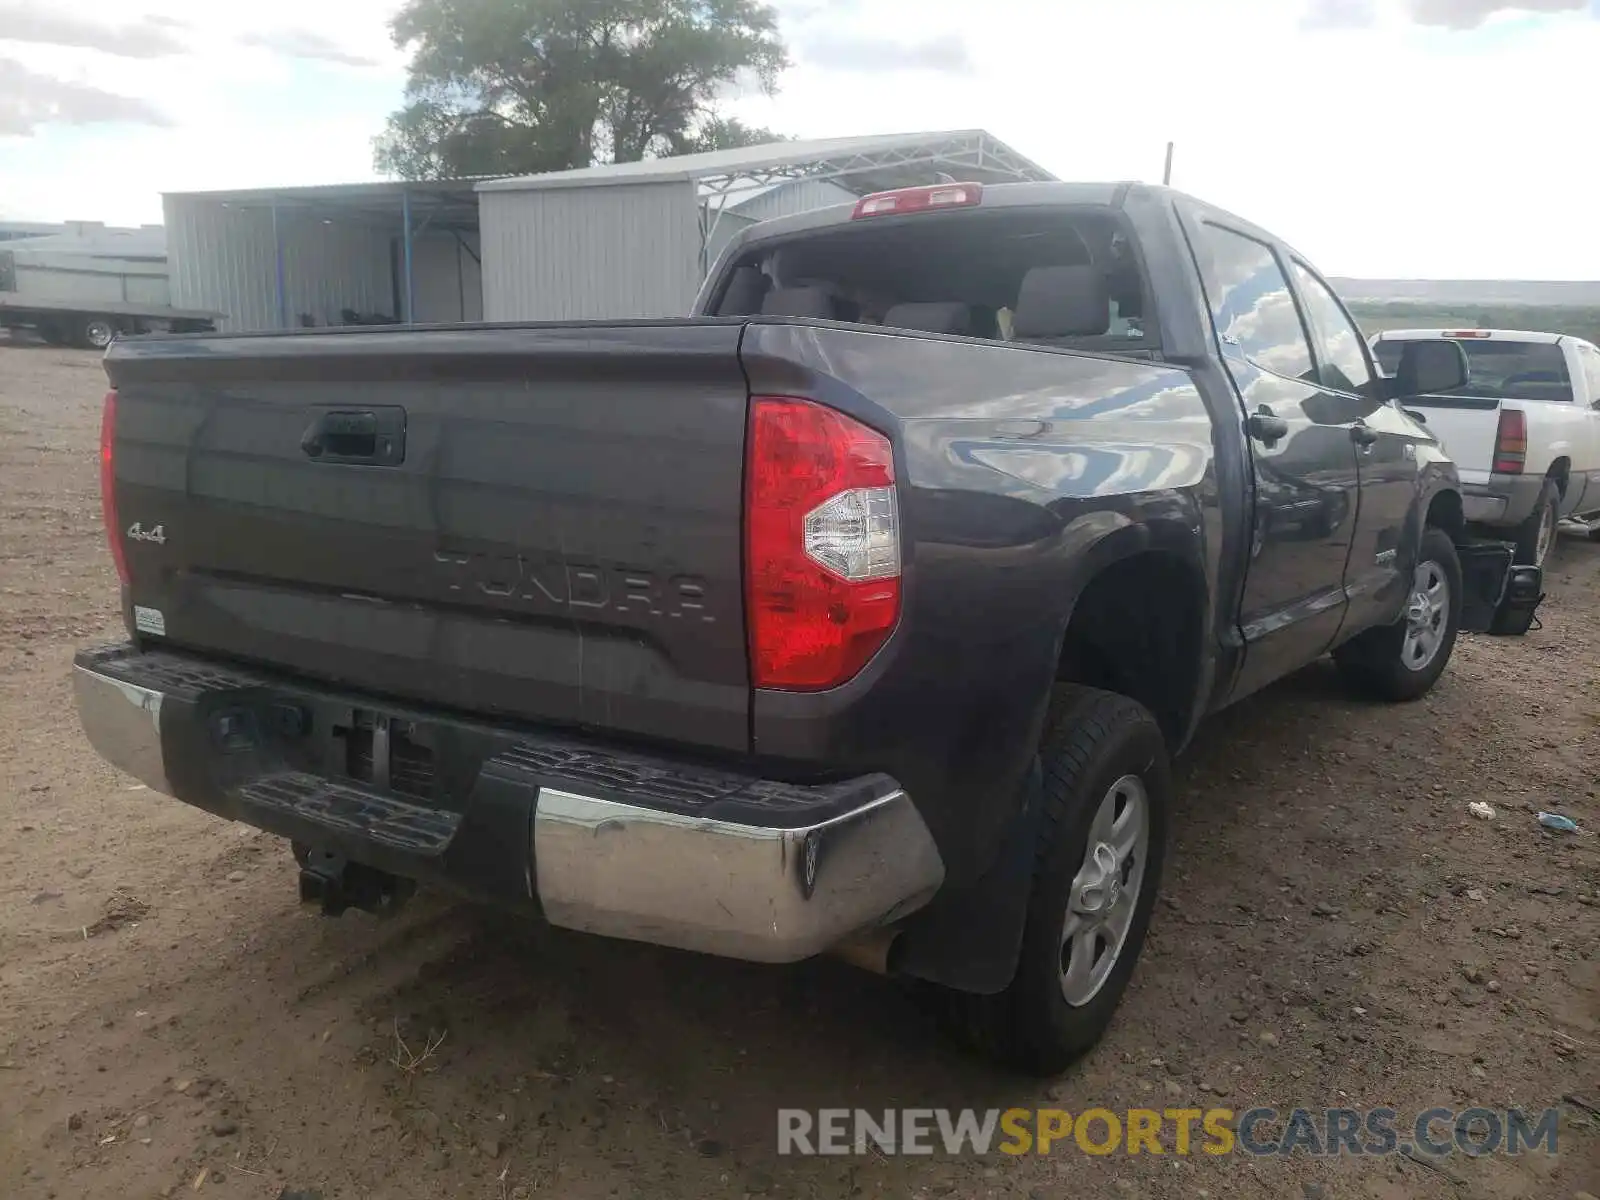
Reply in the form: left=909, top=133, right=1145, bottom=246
left=373, top=0, right=789, bottom=179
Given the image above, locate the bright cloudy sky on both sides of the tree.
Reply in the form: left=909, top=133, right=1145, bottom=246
left=0, top=0, right=1600, bottom=278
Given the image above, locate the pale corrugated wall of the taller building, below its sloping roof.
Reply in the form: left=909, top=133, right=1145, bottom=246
left=478, top=181, right=701, bottom=322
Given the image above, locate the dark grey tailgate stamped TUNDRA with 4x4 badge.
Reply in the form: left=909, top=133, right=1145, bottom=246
left=106, top=320, right=750, bottom=750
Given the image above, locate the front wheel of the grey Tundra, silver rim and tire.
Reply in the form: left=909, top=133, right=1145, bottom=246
left=1333, top=528, right=1462, bottom=701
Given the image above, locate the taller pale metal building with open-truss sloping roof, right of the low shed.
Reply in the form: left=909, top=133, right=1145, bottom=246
left=477, top=130, right=1054, bottom=322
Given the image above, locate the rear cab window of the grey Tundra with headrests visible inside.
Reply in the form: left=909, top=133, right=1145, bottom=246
left=710, top=205, right=1160, bottom=357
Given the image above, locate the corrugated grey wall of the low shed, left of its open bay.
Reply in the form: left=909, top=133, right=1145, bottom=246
left=165, top=195, right=398, bottom=333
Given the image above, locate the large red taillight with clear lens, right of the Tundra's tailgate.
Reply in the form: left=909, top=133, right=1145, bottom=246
left=744, top=397, right=901, bottom=691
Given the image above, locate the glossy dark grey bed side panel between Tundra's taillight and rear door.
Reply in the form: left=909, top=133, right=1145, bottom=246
left=741, top=322, right=1222, bottom=878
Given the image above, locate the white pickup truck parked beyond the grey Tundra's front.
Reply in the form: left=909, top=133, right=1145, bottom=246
left=1371, top=330, right=1600, bottom=566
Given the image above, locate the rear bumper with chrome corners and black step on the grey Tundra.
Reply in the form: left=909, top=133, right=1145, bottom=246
left=72, top=648, right=944, bottom=962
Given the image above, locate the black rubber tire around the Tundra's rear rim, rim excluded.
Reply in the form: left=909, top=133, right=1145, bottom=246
left=944, top=685, right=1171, bottom=1075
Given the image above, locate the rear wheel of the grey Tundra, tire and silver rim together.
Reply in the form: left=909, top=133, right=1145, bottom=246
left=949, top=685, right=1171, bottom=1075
